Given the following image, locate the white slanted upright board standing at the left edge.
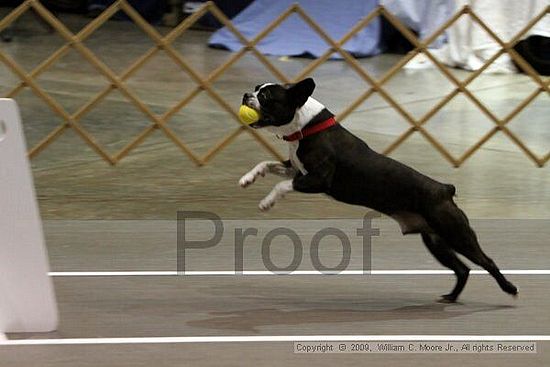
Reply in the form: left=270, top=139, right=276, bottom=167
left=0, top=98, right=57, bottom=334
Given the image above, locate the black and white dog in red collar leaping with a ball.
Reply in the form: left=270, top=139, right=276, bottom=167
left=239, top=79, right=518, bottom=302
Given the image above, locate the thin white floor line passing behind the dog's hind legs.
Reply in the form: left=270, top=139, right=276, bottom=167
left=49, top=269, right=550, bottom=277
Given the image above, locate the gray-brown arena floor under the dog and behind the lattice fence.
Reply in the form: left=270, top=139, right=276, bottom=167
left=0, top=10, right=550, bottom=366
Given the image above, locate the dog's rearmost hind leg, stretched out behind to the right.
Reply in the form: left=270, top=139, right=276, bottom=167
left=429, top=201, right=518, bottom=296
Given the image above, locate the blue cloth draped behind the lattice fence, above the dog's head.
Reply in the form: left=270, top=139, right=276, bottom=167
left=209, top=0, right=381, bottom=58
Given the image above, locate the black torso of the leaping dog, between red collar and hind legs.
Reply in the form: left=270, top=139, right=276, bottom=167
left=293, top=115, right=455, bottom=216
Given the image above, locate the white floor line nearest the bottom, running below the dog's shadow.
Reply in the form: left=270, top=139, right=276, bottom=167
left=0, top=335, right=550, bottom=346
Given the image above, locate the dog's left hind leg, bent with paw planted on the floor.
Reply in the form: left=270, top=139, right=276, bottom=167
left=421, top=233, right=470, bottom=303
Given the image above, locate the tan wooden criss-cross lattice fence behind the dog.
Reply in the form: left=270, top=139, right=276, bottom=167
left=0, top=0, right=550, bottom=167
